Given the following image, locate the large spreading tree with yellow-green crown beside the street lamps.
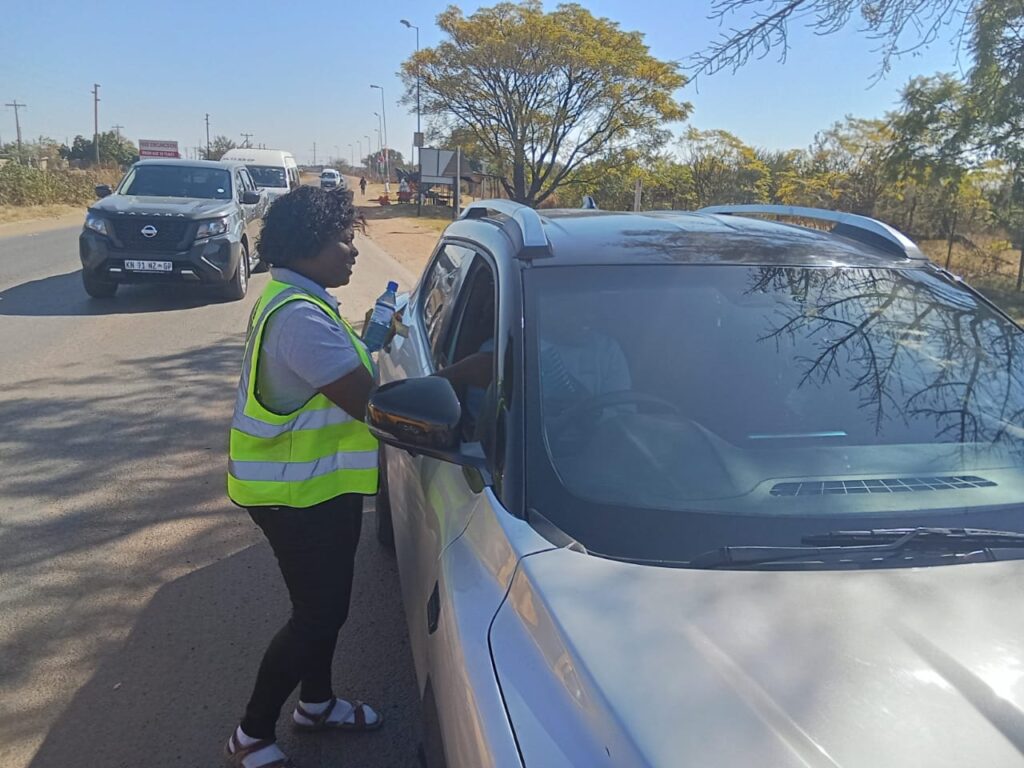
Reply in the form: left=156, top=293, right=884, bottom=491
left=402, top=0, right=690, bottom=205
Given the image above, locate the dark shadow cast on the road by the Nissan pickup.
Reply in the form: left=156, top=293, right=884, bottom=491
left=0, top=269, right=233, bottom=316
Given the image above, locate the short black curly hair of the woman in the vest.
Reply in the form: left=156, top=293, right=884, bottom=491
left=258, top=186, right=355, bottom=267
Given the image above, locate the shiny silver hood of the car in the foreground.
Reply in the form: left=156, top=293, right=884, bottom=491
left=490, top=549, right=1024, bottom=768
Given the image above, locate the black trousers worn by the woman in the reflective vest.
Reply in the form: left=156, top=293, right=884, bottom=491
left=242, top=494, right=362, bottom=738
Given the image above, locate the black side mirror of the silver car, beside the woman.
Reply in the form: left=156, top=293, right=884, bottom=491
left=367, top=376, right=484, bottom=469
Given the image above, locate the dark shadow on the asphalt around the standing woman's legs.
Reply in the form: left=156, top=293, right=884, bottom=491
left=31, top=505, right=420, bottom=768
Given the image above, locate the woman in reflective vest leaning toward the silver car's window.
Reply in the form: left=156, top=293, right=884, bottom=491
left=227, top=186, right=490, bottom=768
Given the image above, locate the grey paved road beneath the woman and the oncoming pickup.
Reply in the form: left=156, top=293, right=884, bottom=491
left=0, top=227, right=419, bottom=768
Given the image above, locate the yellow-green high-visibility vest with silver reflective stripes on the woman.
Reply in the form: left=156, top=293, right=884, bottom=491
left=227, top=281, right=377, bottom=507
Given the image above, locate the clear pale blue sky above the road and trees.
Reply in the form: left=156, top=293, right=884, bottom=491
left=0, top=0, right=963, bottom=162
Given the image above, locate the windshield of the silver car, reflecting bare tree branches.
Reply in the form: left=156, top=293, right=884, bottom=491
left=525, top=265, right=1024, bottom=563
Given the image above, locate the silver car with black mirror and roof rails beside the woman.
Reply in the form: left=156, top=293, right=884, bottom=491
left=368, top=201, right=1024, bottom=768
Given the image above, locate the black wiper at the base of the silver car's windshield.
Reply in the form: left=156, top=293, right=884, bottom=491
left=688, top=527, right=1024, bottom=568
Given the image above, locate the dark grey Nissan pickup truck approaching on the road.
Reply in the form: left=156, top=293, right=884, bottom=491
left=79, top=160, right=267, bottom=300
